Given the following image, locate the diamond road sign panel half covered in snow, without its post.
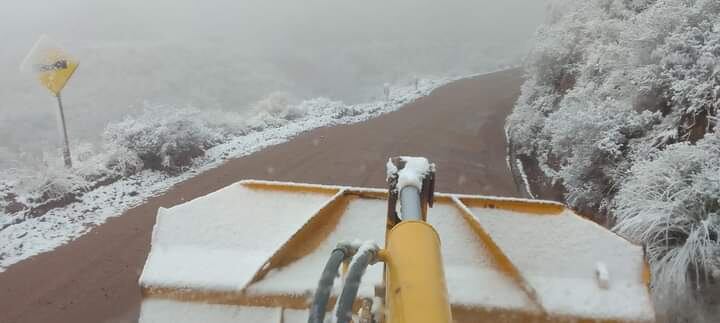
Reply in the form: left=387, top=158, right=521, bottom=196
left=20, top=35, right=79, bottom=96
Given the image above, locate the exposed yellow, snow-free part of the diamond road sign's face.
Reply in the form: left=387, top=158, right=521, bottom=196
left=34, top=49, right=79, bottom=95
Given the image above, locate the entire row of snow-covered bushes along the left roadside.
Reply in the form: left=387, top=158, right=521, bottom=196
left=0, top=92, right=366, bottom=216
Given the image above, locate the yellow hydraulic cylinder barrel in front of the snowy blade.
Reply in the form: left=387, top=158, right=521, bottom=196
left=385, top=221, right=452, bottom=323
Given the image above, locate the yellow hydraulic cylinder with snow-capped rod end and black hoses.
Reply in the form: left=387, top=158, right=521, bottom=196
left=308, top=157, right=452, bottom=323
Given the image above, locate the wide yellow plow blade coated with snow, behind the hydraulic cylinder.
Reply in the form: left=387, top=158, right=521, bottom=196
left=140, top=180, right=654, bottom=323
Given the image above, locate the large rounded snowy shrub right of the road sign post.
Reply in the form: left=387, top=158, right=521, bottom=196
left=103, top=106, right=224, bottom=172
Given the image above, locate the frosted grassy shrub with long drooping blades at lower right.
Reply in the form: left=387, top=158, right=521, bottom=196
left=614, top=134, right=720, bottom=322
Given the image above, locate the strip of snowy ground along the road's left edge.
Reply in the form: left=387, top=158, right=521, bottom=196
left=0, top=73, right=490, bottom=271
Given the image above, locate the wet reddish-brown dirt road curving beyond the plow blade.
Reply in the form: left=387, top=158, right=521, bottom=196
left=0, top=70, right=522, bottom=323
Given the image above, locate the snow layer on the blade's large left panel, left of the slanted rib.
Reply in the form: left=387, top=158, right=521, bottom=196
left=140, top=184, right=331, bottom=291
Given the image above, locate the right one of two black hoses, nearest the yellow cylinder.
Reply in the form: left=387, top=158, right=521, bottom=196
left=335, top=248, right=377, bottom=323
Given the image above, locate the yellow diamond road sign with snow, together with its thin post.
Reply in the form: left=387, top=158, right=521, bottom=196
left=20, top=35, right=79, bottom=168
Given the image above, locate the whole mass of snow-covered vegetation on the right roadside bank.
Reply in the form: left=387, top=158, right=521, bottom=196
left=508, top=0, right=720, bottom=321
